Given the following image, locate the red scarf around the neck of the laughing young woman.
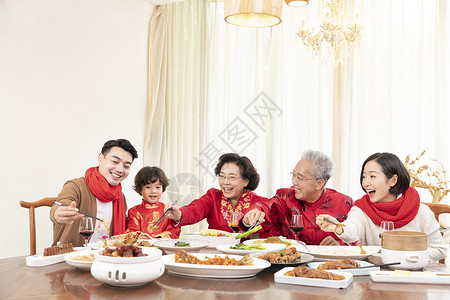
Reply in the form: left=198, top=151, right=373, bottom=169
left=355, top=187, right=420, bottom=228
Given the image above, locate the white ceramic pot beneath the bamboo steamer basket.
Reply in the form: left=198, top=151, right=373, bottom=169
left=381, top=248, right=429, bottom=270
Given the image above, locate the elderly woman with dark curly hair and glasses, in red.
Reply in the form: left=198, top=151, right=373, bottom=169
left=168, top=153, right=267, bottom=232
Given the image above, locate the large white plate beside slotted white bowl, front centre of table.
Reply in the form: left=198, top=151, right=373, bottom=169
left=161, top=253, right=270, bottom=278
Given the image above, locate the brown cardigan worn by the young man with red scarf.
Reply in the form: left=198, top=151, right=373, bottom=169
left=50, top=177, right=127, bottom=247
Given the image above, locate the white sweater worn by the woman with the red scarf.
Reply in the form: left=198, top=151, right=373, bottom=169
left=338, top=203, right=447, bottom=261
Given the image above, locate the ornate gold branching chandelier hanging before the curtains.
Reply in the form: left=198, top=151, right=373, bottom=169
left=297, top=0, right=363, bottom=65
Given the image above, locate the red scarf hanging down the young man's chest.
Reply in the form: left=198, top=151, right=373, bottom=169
left=85, top=167, right=126, bottom=235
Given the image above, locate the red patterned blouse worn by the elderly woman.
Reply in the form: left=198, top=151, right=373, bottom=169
left=178, top=188, right=274, bottom=237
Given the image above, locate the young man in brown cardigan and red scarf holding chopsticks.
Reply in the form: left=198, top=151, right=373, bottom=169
left=50, top=139, right=138, bottom=246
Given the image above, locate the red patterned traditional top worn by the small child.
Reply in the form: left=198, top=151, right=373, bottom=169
left=125, top=200, right=181, bottom=239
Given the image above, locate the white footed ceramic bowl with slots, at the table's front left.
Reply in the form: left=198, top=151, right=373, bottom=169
left=91, top=247, right=165, bottom=286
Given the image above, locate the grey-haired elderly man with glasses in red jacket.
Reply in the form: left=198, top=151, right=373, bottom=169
left=242, top=150, right=353, bottom=245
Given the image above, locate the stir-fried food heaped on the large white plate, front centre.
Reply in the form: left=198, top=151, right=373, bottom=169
left=175, top=250, right=253, bottom=266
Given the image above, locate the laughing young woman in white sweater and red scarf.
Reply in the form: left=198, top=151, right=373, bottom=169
left=316, top=152, right=447, bottom=261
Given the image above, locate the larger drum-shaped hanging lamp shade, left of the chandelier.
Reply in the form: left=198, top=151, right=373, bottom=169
left=224, top=0, right=283, bottom=27
